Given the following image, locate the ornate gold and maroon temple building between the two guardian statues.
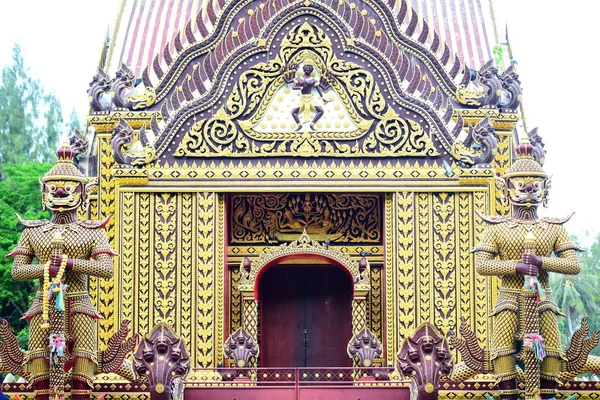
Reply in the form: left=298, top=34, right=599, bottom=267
left=2, top=0, right=597, bottom=400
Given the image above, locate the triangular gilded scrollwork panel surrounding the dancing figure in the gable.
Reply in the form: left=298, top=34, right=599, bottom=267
left=175, top=23, right=438, bottom=157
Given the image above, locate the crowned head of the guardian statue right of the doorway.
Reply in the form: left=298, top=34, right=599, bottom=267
left=498, top=139, right=550, bottom=208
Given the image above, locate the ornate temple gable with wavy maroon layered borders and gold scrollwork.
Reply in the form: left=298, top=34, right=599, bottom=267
left=105, top=0, right=519, bottom=166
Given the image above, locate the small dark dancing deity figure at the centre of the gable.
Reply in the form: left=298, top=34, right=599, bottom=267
left=284, top=57, right=330, bottom=131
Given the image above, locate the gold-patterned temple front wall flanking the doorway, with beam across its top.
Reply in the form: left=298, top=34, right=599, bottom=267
left=89, top=112, right=502, bottom=367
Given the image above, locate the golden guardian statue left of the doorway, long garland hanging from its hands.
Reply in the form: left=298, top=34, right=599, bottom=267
left=9, top=146, right=116, bottom=400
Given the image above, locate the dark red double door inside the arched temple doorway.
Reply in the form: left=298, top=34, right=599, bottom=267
left=259, top=259, right=353, bottom=367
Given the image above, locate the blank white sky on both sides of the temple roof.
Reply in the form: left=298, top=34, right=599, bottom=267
left=0, top=0, right=600, bottom=241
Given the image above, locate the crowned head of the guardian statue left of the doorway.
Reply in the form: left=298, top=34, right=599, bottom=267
left=40, top=144, right=96, bottom=212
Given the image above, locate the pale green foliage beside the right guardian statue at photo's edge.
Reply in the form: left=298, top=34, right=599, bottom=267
left=550, top=233, right=600, bottom=354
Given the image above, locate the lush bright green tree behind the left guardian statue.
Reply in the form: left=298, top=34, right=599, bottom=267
left=0, top=161, right=52, bottom=348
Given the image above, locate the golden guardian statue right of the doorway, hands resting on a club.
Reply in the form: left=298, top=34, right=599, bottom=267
left=474, top=140, right=580, bottom=400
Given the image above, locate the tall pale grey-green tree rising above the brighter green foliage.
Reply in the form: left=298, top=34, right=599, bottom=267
left=0, top=45, right=64, bottom=165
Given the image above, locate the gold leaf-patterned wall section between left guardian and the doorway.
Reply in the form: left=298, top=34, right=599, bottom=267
left=112, top=189, right=218, bottom=367
